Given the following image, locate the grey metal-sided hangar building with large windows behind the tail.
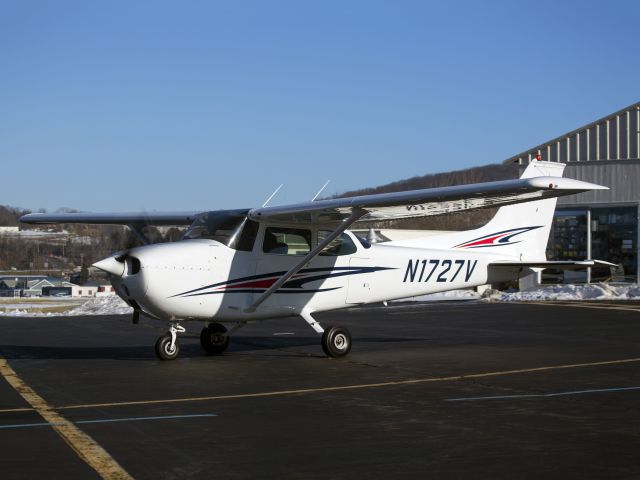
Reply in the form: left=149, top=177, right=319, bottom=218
left=503, top=102, right=640, bottom=283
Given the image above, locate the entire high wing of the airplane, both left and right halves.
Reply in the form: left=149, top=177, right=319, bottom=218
left=20, top=176, right=608, bottom=226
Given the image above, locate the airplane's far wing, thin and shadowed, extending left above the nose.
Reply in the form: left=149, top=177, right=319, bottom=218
left=20, top=211, right=201, bottom=226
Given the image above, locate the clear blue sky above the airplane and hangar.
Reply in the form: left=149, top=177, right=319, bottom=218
left=0, top=0, right=640, bottom=211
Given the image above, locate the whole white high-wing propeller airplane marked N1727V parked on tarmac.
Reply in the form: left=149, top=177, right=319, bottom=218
left=20, top=161, right=607, bottom=360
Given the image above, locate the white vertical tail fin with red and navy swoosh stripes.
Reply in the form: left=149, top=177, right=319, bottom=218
left=393, top=161, right=565, bottom=262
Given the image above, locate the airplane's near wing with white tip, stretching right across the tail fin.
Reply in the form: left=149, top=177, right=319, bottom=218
left=249, top=176, right=608, bottom=224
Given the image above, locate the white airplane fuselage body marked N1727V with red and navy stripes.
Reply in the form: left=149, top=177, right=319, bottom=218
left=107, top=233, right=504, bottom=321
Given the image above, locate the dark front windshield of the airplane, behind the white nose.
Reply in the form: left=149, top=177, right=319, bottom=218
left=182, top=210, right=258, bottom=251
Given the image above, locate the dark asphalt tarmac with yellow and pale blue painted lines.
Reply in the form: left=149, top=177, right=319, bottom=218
left=0, top=302, right=640, bottom=480
